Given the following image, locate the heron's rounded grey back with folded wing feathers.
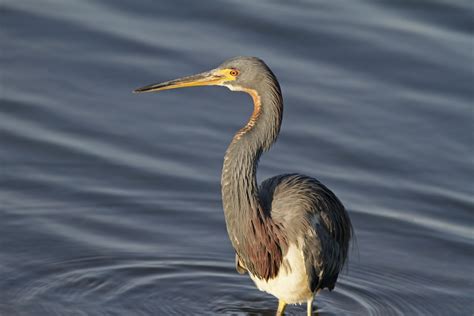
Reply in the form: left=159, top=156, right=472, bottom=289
left=259, top=174, right=352, bottom=292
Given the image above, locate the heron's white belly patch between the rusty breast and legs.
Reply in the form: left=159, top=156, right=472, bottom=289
left=249, top=244, right=314, bottom=304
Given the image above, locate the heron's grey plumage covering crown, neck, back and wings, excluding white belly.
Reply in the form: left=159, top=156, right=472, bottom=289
left=220, top=57, right=352, bottom=292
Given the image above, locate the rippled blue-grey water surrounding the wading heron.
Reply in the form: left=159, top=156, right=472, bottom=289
left=0, top=0, right=474, bottom=316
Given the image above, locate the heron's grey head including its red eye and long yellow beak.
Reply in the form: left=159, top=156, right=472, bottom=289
left=134, top=57, right=273, bottom=93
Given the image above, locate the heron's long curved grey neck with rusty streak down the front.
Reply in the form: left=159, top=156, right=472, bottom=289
left=221, top=81, right=283, bottom=279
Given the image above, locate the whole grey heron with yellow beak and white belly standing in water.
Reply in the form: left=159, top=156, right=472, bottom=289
left=134, top=57, right=353, bottom=315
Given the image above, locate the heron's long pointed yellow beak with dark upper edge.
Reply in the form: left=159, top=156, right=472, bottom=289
left=133, top=70, right=226, bottom=93
